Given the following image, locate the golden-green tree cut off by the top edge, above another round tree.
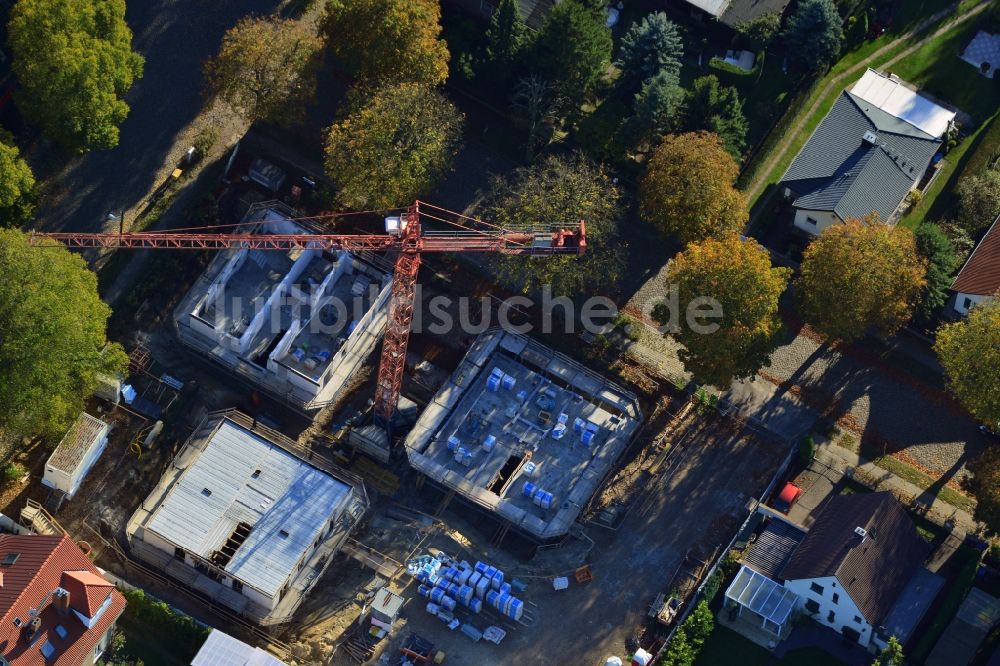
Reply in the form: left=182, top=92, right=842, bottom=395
left=323, top=0, right=448, bottom=86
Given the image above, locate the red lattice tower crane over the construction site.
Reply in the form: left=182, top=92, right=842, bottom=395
left=30, top=201, right=587, bottom=429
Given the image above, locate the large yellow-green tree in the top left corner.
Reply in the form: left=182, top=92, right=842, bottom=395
left=8, top=0, right=143, bottom=152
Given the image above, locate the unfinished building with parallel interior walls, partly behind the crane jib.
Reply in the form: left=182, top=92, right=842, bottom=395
left=174, top=203, right=392, bottom=412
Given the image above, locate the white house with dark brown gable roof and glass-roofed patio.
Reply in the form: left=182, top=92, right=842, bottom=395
left=726, top=492, right=944, bottom=649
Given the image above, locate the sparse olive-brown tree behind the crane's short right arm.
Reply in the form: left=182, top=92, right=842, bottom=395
left=480, top=153, right=621, bottom=295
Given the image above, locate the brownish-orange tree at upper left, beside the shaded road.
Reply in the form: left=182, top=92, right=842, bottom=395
left=205, top=17, right=323, bottom=121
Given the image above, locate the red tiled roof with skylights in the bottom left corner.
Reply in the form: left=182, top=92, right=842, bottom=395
left=0, top=534, right=125, bottom=666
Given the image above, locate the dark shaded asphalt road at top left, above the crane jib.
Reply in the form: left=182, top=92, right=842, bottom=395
left=29, top=0, right=282, bottom=231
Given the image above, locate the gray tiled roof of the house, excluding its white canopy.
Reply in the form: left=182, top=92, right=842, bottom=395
left=781, top=91, right=941, bottom=220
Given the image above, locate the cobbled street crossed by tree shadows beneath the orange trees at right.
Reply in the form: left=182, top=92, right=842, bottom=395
left=628, top=262, right=986, bottom=480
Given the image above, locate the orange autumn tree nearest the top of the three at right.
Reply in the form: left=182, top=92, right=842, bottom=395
left=639, top=132, right=748, bottom=243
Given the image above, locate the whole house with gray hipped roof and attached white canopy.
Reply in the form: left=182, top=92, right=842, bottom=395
left=779, top=70, right=956, bottom=235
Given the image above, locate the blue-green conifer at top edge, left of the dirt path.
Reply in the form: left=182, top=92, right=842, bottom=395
left=782, top=0, right=844, bottom=74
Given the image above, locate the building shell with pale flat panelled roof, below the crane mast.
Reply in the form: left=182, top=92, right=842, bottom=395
left=126, top=412, right=368, bottom=625
